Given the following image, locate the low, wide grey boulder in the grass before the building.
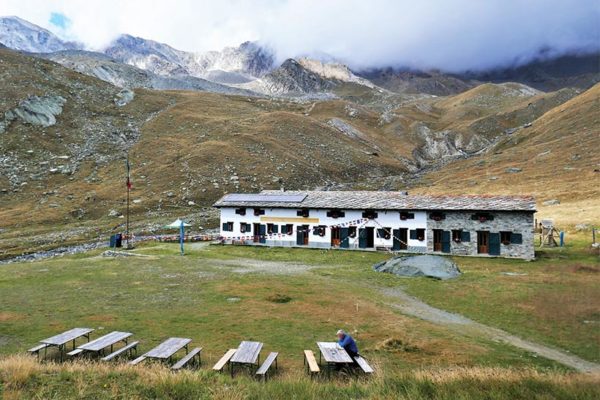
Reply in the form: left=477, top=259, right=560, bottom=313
left=373, top=255, right=461, bottom=280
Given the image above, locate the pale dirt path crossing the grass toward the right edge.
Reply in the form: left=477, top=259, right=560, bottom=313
left=381, top=289, right=600, bottom=373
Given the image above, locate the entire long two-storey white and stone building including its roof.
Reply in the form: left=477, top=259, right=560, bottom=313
left=214, top=191, right=535, bottom=259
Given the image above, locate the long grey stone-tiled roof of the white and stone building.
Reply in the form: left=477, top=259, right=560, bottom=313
left=214, top=190, right=535, bottom=211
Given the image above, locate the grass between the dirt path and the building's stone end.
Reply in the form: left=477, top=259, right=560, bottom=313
left=392, top=234, right=600, bottom=362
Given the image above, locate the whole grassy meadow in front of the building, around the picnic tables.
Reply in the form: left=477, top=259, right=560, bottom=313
left=0, top=237, right=600, bottom=399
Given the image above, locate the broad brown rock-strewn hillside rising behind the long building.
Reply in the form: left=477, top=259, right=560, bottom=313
left=0, top=49, right=598, bottom=256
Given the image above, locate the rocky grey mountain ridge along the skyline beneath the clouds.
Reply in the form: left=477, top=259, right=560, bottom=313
left=0, top=17, right=600, bottom=98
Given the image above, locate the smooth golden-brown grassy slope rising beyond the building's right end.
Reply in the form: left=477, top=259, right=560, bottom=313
left=419, top=84, right=600, bottom=224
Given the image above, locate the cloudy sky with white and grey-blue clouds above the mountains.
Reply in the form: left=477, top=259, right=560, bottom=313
left=0, top=0, right=600, bottom=71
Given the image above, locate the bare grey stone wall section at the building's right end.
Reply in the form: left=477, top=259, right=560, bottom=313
left=427, top=211, right=535, bottom=260
